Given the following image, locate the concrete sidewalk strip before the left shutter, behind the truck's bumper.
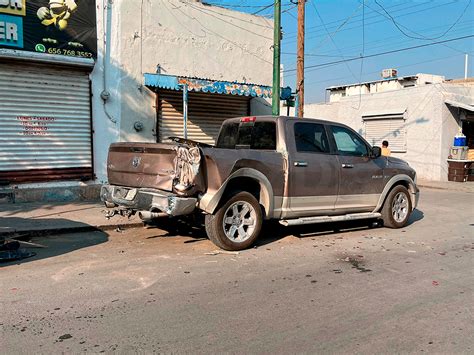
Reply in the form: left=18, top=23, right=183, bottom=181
left=0, top=202, right=143, bottom=235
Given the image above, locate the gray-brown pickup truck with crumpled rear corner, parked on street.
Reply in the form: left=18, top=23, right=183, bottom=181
left=101, top=116, right=419, bottom=250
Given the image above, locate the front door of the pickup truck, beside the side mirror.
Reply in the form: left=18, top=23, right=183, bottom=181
left=330, top=125, right=383, bottom=213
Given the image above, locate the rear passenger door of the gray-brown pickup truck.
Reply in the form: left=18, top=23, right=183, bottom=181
left=287, top=120, right=339, bottom=217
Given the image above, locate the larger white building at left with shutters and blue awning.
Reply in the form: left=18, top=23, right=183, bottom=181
left=0, top=0, right=273, bottom=202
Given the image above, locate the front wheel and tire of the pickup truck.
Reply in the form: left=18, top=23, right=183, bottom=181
left=381, top=185, right=412, bottom=228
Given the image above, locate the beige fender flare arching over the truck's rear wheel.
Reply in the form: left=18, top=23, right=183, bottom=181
left=199, top=168, right=274, bottom=219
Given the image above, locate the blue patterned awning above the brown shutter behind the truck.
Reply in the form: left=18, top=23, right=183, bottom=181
left=145, top=74, right=272, bottom=98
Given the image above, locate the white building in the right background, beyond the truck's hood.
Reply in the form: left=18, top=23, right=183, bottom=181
left=305, top=74, right=474, bottom=181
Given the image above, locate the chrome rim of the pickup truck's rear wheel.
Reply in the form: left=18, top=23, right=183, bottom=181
left=222, top=201, right=257, bottom=243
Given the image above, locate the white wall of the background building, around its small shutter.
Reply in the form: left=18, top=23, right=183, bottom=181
left=305, top=84, right=466, bottom=181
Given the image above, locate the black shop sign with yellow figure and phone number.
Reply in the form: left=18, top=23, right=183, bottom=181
left=0, top=0, right=97, bottom=58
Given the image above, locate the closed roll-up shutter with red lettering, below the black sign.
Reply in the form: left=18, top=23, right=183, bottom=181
left=0, top=63, right=93, bottom=182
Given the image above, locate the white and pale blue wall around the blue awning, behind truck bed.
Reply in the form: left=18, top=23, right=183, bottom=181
left=91, top=0, right=273, bottom=183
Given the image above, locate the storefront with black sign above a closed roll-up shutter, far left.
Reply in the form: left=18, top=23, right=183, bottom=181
left=0, top=0, right=97, bottom=192
